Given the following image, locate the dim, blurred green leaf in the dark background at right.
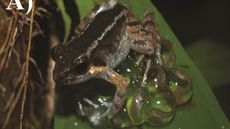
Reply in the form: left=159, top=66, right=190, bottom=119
left=186, top=39, right=230, bottom=88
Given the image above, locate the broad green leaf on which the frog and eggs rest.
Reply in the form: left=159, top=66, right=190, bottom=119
left=55, top=0, right=230, bottom=129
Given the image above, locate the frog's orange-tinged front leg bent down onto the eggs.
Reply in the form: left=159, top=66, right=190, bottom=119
left=89, top=66, right=128, bottom=119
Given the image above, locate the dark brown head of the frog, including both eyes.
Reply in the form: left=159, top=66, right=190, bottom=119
left=51, top=45, right=89, bottom=85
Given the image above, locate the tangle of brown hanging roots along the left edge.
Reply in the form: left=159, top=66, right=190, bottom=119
left=0, top=0, right=54, bottom=129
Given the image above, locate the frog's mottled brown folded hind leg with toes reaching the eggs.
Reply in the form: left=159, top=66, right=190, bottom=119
left=126, top=10, right=163, bottom=86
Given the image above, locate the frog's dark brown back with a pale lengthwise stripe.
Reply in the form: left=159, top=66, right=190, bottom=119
left=69, top=4, right=127, bottom=59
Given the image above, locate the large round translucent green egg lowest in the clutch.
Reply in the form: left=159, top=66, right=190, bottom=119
left=142, top=91, right=176, bottom=126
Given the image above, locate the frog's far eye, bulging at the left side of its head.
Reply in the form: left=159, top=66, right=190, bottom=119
left=51, top=45, right=63, bottom=62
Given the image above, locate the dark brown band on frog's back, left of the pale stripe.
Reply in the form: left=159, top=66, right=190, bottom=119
left=69, top=4, right=126, bottom=53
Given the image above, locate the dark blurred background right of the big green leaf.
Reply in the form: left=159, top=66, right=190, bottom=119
left=152, top=0, right=230, bottom=120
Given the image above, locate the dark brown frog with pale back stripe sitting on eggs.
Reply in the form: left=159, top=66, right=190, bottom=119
left=51, top=0, right=162, bottom=119
